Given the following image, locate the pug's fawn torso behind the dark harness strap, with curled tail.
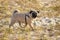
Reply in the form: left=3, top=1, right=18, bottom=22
left=11, top=11, right=26, bottom=23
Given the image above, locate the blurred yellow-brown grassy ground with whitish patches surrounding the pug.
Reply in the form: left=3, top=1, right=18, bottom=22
left=0, top=0, right=60, bottom=40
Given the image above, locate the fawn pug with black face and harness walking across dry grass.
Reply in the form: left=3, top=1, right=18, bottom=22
left=9, top=10, right=39, bottom=30
